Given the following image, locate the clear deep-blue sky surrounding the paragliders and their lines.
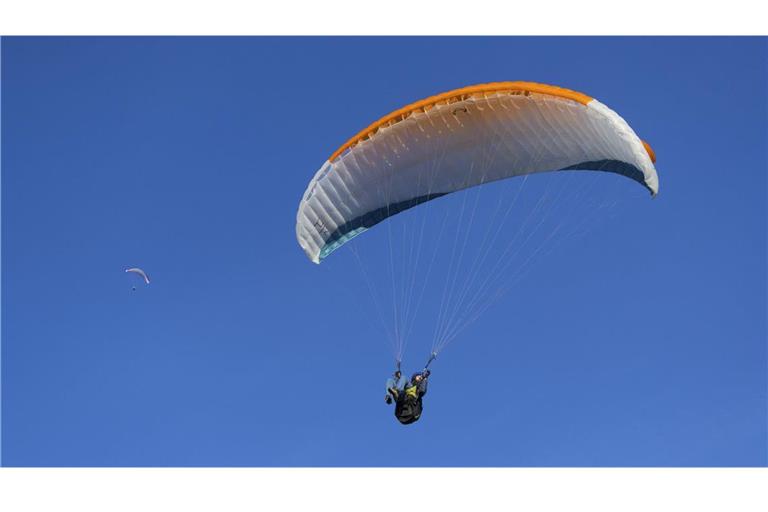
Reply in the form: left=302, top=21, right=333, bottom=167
left=2, top=37, right=768, bottom=466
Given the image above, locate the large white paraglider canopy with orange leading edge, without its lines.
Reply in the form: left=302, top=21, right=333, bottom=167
left=296, top=82, right=659, bottom=263
